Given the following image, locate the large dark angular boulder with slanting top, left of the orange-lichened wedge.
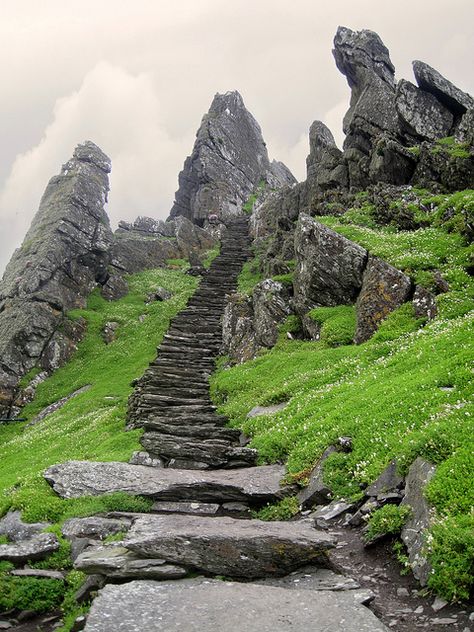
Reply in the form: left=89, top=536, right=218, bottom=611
left=293, top=214, right=367, bottom=312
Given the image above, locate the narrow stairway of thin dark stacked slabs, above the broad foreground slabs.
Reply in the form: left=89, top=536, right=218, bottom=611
left=128, top=217, right=257, bottom=469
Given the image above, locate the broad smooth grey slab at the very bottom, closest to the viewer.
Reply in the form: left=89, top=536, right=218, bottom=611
left=85, top=578, right=388, bottom=632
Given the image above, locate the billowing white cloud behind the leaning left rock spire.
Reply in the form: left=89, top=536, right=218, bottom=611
left=0, top=61, right=192, bottom=269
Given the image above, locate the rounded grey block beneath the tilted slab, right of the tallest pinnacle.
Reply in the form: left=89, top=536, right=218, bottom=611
left=396, top=79, right=454, bottom=140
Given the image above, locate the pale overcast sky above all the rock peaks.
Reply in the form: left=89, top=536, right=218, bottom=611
left=0, top=0, right=474, bottom=273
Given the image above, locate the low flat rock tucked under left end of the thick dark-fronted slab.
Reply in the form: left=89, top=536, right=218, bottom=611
left=74, top=543, right=187, bottom=580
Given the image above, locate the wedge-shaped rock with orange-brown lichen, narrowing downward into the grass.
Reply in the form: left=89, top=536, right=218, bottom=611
left=354, top=255, right=412, bottom=344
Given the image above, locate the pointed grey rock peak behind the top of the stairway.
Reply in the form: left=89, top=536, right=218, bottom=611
left=170, top=92, right=295, bottom=225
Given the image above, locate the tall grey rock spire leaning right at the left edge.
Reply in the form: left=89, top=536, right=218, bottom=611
left=0, top=141, right=112, bottom=414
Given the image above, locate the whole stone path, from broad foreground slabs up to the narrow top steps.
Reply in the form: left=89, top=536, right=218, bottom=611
left=45, top=218, right=387, bottom=632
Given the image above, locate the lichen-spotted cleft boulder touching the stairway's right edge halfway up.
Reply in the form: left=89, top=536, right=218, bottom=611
left=222, top=279, right=292, bottom=363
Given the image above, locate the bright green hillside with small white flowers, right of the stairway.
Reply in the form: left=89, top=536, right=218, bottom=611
left=213, top=192, right=474, bottom=599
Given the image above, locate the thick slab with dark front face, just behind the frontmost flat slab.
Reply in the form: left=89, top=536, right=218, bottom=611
left=123, top=514, right=335, bottom=578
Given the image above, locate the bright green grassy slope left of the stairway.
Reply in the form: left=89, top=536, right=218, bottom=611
left=0, top=264, right=197, bottom=630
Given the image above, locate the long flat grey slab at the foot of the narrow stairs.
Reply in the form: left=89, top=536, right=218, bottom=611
left=44, top=461, right=292, bottom=503
